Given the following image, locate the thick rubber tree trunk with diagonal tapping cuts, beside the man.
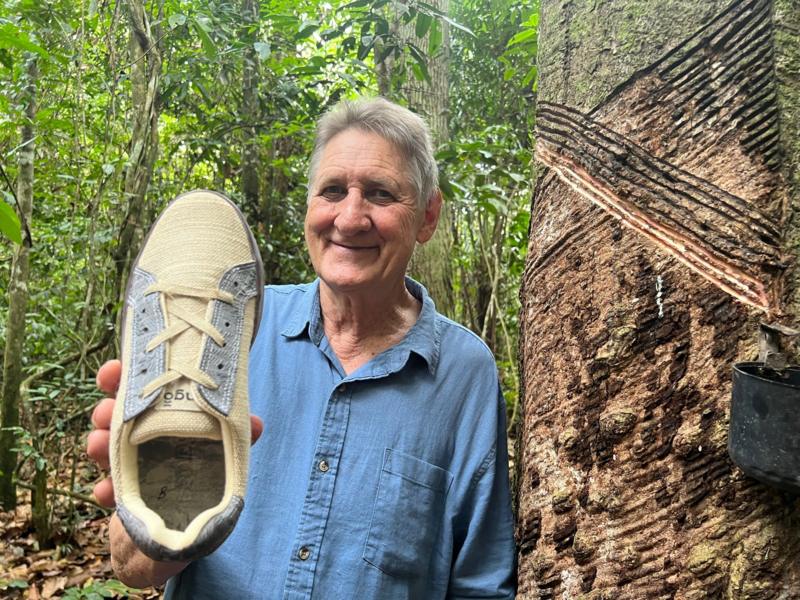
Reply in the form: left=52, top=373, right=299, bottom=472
left=517, top=0, right=800, bottom=600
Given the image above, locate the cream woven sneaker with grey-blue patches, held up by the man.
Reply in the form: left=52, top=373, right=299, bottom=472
left=110, top=191, right=263, bottom=561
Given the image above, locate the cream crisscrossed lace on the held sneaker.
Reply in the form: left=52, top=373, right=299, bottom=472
left=142, top=283, right=234, bottom=397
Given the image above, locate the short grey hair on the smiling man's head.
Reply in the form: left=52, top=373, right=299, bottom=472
left=308, top=97, right=439, bottom=208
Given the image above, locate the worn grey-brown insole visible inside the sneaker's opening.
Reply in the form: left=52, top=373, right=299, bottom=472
left=139, top=437, right=225, bottom=531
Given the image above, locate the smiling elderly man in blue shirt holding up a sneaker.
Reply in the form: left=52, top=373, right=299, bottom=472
left=89, top=99, right=515, bottom=600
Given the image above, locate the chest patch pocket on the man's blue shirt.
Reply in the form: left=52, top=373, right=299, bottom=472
left=364, top=448, right=453, bottom=577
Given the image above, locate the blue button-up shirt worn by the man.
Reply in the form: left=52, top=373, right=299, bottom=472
left=166, top=280, right=515, bottom=600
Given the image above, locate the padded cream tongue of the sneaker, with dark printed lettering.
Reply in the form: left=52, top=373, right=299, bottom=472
left=129, top=380, right=222, bottom=444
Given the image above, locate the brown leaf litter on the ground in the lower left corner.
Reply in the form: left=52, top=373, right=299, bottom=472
left=0, top=490, right=160, bottom=600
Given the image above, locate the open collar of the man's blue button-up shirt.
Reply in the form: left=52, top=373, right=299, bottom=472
left=281, top=277, right=441, bottom=374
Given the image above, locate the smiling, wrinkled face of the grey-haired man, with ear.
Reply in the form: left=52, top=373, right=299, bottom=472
left=305, top=129, right=440, bottom=292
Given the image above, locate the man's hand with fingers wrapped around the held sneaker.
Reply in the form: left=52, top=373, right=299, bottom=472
left=86, top=360, right=264, bottom=587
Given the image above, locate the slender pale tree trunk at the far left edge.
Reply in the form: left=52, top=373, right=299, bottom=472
left=0, top=56, right=39, bottom=510
